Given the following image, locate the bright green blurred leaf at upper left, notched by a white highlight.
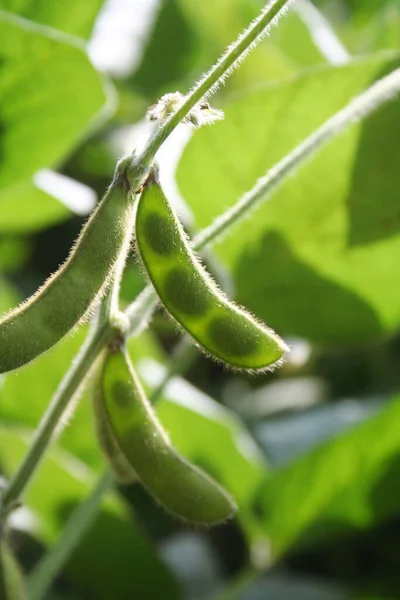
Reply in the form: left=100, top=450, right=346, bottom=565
left=0, top=11, right=107, bottom=230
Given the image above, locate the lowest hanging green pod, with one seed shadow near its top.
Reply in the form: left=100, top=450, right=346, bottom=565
left=102, top=349, right=236, bottom=525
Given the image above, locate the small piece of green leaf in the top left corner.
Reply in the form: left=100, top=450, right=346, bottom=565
left=0, top=0, right=103, bottom=39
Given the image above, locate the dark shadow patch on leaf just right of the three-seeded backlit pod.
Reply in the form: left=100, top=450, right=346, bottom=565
left=235, top=232, right=382, bottom=344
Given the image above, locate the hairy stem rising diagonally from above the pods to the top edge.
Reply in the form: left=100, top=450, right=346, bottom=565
left=138, top=0, right=291, bottom=166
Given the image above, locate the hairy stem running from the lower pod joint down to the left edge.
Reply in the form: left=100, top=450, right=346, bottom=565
left=0, top=326, right=115, bottom=524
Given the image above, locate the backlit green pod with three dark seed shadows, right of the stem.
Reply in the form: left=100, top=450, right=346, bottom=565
left=135, top=175, right=288, bottom=371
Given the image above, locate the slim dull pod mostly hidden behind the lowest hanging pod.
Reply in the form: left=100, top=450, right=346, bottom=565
left=93, top=354, right=137, bottom=485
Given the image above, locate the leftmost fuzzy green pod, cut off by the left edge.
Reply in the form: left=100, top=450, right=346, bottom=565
left=0, top=163, right=133, bottom=373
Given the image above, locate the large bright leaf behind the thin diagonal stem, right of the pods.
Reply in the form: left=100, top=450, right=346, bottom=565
left=178, top=53, right=400, bottom=343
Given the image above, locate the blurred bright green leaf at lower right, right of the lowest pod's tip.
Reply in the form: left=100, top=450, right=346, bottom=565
left=254, top=398, right=400, bottom=558
